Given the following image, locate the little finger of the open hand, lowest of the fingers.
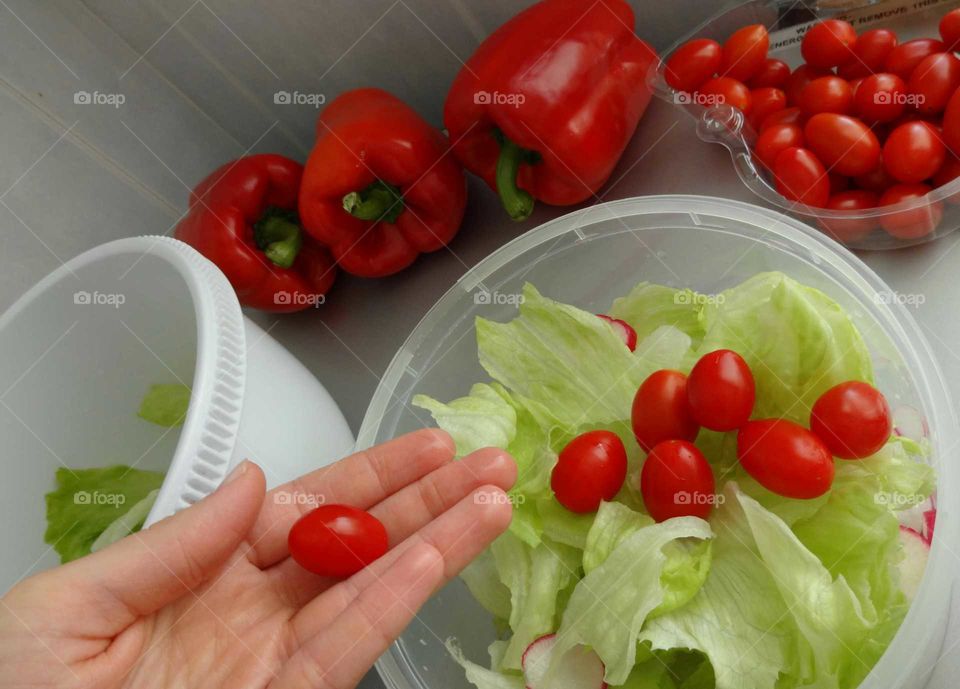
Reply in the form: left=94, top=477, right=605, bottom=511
left=270, top=543, right=443, bottom=689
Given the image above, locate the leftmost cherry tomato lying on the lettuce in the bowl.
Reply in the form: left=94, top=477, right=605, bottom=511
left=550, top=431, right=627, bottom=514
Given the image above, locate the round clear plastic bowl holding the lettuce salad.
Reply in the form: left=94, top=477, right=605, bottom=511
left=358, top=196, right=960, bottom=689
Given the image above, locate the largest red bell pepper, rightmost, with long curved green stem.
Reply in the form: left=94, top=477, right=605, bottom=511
left=443, top=0, right=656, bottom=220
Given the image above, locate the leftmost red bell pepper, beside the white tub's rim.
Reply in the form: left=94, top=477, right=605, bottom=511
left=174, top=154, right=337, bottom=312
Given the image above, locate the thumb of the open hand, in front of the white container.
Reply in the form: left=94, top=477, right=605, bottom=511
left=58, top=461, right=266, bottom=629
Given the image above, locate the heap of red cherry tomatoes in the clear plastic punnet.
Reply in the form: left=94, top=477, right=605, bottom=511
left=664, top=9, right=960, bottom=242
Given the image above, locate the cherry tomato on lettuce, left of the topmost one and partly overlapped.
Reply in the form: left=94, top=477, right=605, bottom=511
left=630, top=369, right=700, bottom=452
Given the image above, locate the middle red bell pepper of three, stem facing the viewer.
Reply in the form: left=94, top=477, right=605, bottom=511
left=300, top=88, right=467, bottom=277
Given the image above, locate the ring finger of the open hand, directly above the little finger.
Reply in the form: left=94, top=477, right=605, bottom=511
left=292, top=486, right=512, bottom=641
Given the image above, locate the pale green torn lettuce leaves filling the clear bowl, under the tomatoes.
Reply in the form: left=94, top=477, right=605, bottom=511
left=414, top=273, right=934, bottom=689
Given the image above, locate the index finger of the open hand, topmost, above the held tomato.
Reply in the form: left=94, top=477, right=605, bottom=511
left=249, top=429, right=454, bottom=567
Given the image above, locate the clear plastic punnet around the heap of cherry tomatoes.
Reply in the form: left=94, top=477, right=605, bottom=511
left=651, top=0, right=960, bottom=249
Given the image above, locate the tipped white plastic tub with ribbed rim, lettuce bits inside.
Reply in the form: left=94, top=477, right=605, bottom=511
left=0, top=237, right=354, bottom=591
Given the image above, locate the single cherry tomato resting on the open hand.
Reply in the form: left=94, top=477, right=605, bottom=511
left=287, top=505, right=388, bottom=579
